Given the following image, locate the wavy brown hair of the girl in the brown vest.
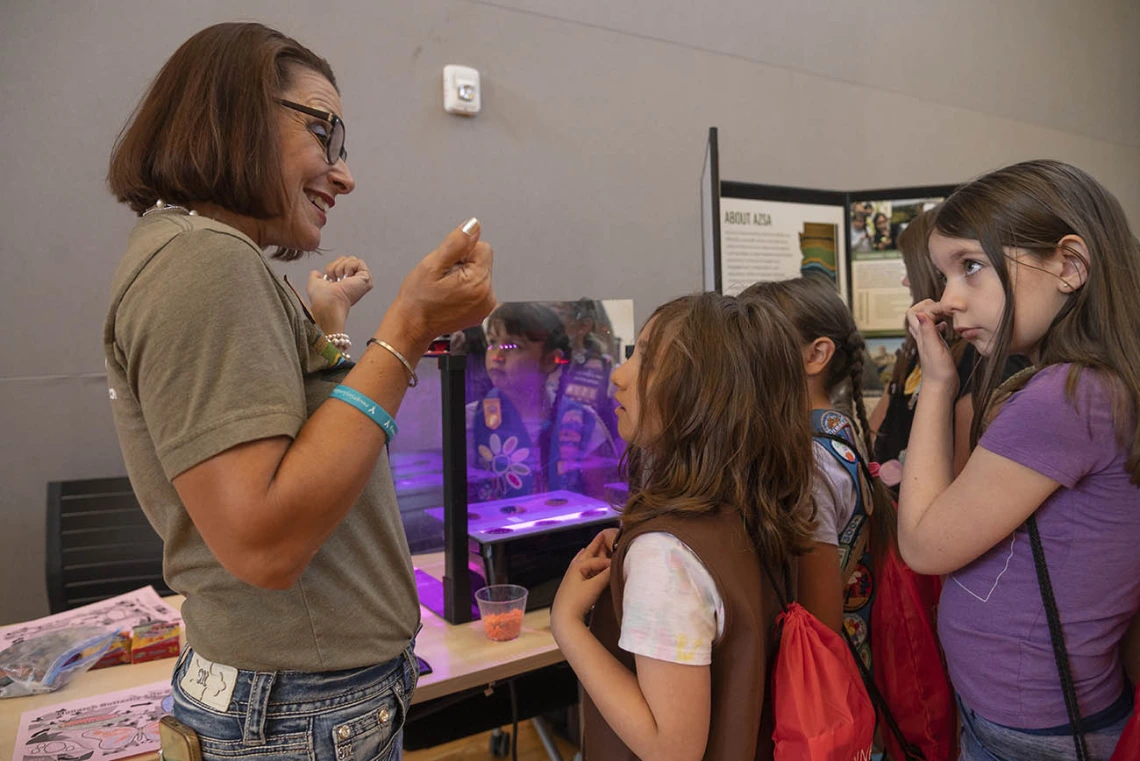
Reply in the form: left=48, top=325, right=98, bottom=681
left=621, top=293, right=813, bottom=567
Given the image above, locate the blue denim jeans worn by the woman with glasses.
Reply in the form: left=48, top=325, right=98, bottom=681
left=172, top=640, right=420, bottom=761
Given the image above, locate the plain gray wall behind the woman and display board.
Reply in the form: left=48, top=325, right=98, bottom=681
left=0, top=0, right=1140, bottom=623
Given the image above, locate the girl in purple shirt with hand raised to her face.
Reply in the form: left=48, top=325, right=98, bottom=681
left=898, top=161, right=1140, bottom=761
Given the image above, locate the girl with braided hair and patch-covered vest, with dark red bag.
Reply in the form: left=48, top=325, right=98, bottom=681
left=741, top=277, right=956, bottom=761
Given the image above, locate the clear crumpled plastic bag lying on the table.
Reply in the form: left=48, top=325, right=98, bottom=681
left=0, top=627, right=117, bottom=697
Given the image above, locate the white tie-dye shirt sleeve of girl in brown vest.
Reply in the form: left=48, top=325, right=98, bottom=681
left=618, top=531, right=724, bottom=665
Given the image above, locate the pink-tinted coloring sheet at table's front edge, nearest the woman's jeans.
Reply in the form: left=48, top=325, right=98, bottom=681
left=13, top=681, right=172, bottom=761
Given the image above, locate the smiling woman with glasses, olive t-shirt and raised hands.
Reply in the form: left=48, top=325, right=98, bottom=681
left=104, top=24, right=495, bottom=761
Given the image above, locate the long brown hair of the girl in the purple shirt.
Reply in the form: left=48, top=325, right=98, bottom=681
left=933, top=161, right=1140, bottom=485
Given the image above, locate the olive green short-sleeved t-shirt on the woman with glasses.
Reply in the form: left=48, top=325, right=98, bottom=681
left=104, top=211, right=420, bottom=671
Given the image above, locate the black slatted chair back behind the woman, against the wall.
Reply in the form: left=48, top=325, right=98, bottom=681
left=47, top=478, right=173, bottom=613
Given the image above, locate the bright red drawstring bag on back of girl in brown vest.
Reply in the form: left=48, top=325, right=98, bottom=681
left=765, top=558, right=874, bottom=761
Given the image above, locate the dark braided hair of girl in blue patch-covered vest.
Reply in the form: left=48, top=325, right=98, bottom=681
left=740, top=276, right=897, bottom=557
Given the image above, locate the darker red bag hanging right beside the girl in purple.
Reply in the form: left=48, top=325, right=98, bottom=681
left=871, top=548, right=958, bottom=761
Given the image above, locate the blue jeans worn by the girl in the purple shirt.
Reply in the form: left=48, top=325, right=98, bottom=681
left=958, top=693, right=1132, bottom=761
